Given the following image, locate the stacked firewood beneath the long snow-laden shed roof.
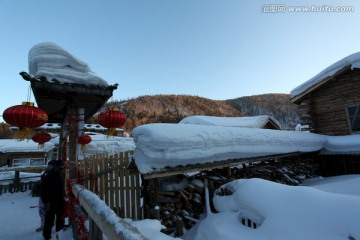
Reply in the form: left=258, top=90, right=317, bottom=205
left=148, top=156, right=317, bottom=236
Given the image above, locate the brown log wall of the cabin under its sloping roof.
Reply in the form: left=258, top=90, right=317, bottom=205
left=299, top=69, right=360, bottom=136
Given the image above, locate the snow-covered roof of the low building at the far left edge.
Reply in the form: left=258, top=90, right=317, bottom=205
left=0, top=139, right=54, bottom=153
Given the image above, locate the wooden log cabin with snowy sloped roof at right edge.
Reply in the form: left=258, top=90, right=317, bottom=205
left=291, top=52, right=360, bottom=136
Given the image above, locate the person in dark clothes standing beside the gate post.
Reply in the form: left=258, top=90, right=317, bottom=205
left=41, top=160, right=65, bottom=240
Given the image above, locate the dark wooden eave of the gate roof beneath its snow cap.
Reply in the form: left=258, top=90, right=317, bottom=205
left=21, top=73, right=117, bottom=123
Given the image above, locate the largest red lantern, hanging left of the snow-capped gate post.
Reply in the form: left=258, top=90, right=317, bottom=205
left=3, top=102, right=48, bottom=141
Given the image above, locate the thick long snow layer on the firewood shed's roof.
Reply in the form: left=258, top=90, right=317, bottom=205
left=132, top=123, right=326, bottom=174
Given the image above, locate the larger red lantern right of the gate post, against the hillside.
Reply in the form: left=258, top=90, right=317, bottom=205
left=98, top=108, right=126, bottom=136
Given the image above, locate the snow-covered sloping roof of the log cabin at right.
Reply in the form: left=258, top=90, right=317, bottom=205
left=290, top=52, right=360, bottom=100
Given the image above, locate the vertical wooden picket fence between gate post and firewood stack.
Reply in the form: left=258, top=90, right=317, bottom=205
left=78, top=152, right=142, bottom=220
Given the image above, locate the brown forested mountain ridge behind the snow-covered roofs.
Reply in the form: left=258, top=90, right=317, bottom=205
left=102, top=94, right=299, bottom=132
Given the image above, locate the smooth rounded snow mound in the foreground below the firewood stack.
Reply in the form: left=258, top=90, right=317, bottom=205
left=184, top=178, right=360, bottom=240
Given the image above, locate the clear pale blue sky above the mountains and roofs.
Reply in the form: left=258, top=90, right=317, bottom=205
left=0, top=0, right=360, bottom=119
